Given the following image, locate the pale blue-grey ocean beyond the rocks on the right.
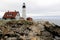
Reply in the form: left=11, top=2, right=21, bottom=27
left=32, top=16, right=60, bottom=26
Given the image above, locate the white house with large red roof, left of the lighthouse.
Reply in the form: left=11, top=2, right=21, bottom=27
left=3, top=11, right=20, bottom=20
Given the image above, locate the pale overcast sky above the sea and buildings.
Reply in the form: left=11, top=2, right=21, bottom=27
left=0, top=0, right=60, bottom=18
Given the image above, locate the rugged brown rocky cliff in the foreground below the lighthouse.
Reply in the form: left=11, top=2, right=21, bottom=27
left=0, top=20, right=60, bottom=40
